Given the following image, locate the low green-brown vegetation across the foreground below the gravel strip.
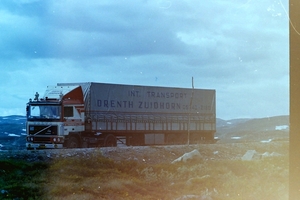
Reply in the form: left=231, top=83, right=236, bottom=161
left=0, top=152, right=288, bottom=200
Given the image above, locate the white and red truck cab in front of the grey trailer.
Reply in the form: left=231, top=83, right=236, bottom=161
left=26, top=86, right=85, bottom=149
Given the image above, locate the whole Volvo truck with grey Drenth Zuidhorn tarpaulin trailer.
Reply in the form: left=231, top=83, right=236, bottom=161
left=26, top=82, right=216, bottom=149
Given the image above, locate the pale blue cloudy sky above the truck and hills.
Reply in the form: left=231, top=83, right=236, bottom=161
left=0, top=0, right=289, bottom=119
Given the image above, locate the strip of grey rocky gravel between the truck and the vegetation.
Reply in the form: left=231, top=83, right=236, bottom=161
left=0, top=140, right=288, bottom=164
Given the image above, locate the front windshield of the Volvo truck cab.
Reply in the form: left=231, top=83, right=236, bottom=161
left=28, top=105, right=61, bottom=120
